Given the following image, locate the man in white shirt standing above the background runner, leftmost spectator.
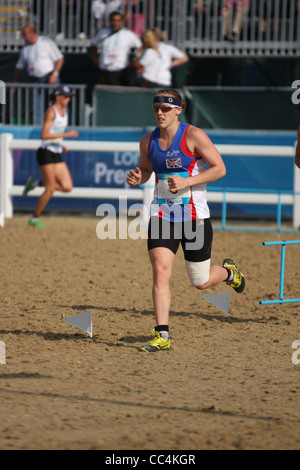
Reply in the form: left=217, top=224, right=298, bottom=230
left=14, top=24, right=64, bottom=124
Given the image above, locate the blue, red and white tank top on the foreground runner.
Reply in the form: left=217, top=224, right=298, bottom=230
left=148, top=122, right=210, bottom=222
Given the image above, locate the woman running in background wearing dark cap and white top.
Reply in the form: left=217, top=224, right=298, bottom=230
left=23, top=85, right=78, bottom=228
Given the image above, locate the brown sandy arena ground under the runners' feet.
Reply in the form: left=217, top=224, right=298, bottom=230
left=0, top=216, right=300, bottom=450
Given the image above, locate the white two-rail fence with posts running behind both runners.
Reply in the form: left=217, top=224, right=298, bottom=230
left=0, top=133, right=300, bottom=228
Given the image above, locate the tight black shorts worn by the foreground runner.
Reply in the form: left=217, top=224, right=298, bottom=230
left=148, top=217, right=213, bottom=262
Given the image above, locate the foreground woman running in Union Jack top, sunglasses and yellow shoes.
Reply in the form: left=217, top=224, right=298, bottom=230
left=126, top=89, right=245, bottom=352
